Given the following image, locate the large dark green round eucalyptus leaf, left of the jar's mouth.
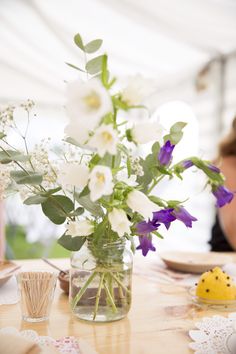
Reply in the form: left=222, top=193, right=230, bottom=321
left=41, top=195, right=74, bottom=225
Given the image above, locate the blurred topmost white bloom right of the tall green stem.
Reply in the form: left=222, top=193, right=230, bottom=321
left=122, top=75, right=155, bottom=106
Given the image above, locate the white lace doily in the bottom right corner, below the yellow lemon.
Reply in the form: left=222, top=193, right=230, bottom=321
left=189, top=313, right=236, bottom=354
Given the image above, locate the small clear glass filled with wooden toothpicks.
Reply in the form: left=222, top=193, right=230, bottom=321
left=17, top=271, right=57, bottom=322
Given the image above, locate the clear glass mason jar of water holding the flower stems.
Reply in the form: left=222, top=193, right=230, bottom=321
left=70, top=240, right=133, bottom=322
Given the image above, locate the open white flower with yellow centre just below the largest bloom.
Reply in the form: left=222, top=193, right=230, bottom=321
left=88, top=124, right=118, bottom=157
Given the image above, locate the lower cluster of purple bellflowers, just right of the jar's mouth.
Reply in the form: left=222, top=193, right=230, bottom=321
left=136, top=207, right=197, bottom=256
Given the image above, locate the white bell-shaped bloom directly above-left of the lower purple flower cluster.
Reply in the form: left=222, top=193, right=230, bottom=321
left=126, top=190, right=159, bottom=219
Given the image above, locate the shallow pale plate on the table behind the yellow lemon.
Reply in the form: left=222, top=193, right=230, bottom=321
left=160, top=251, right=233, bottom=274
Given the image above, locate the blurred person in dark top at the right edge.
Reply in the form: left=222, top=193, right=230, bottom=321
left=209, top=117, right=236, bottom=252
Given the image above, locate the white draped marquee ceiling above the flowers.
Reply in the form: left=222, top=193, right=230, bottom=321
left=0, top=0, right=236, bottom=107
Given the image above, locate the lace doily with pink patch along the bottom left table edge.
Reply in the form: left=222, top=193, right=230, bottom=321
left=0, top=327, right=97, bottom=354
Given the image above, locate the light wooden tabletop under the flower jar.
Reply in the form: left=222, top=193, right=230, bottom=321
left=0, top=255, right=236, bottom=354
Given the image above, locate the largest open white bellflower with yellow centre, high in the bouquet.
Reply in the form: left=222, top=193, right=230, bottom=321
left=65, top=79, right=112, bottom=144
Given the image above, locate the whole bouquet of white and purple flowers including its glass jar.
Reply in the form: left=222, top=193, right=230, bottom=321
left=0, top=34, right=233, bottom=321
